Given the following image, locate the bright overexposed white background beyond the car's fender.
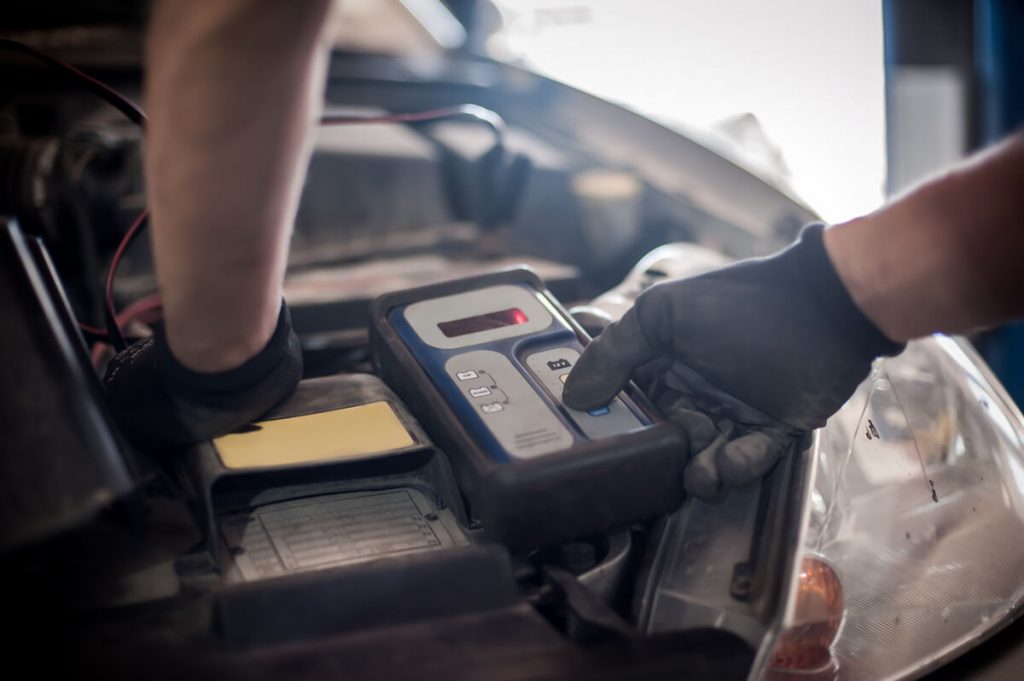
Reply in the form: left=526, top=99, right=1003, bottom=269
left=486, top=0, right=885, bottom=221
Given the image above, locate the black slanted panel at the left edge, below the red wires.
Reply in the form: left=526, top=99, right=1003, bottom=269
left=0, top=222, right=133, bottom=552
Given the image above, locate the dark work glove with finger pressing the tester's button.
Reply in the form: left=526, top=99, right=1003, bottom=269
left=563, top=224, right=904, bottom=499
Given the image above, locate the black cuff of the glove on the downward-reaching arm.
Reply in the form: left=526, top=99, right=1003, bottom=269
left=154, top=301, right=292, bottom=401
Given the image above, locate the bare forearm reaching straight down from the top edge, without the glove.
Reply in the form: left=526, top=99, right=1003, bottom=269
left=145, top=0, right=330, bottom=372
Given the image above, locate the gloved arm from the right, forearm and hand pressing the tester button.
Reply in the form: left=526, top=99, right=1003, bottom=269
left=564, top=134, right=1024, bottom=499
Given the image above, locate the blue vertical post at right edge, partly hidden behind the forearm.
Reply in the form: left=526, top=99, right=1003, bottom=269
left=975, top=0, right=1024, bottom=406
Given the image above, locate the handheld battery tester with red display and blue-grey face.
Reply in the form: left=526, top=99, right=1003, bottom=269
left=372, top=269, right=684, bottom=548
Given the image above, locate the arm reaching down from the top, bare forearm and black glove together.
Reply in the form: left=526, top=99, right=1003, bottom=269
left=105, top=0, right=331, bottom=450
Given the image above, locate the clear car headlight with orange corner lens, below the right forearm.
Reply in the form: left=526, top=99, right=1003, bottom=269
left=755, top=336, right=1024, bottom=681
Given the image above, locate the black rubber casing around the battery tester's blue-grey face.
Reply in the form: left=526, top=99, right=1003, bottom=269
left=371, top=268, right=686, bottom=549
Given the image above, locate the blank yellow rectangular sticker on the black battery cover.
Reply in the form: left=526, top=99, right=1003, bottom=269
left=213, top=401, right=416, bottom=468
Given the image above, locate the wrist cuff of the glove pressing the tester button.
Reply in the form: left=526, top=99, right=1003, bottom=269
left=779, top=223, right=906, bottom=357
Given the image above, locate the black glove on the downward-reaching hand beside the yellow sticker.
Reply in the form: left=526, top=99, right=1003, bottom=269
left=104, top=303, right=302, bottom=451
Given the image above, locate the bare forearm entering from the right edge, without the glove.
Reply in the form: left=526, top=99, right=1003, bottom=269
left=824, top=133, right=1024, bottom=341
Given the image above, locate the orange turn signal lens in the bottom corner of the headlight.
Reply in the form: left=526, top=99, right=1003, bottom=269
left=769, top=557, right=843, bottom=671
